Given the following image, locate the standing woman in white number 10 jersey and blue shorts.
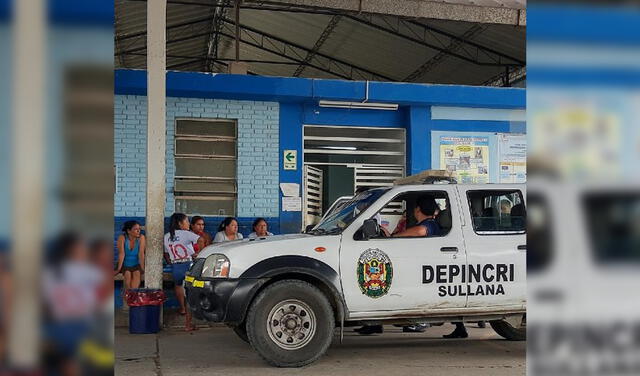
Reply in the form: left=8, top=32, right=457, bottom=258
left=164, top=213, right=204, bottom=331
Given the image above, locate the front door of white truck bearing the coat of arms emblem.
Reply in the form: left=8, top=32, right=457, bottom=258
left=340, top=185, right=467, bottom=318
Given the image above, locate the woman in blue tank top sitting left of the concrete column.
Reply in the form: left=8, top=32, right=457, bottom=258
left=115, top=221, right=147, bottom=290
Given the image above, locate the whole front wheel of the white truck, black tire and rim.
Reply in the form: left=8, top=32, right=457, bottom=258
left=246, top=280, right=335, bottom=367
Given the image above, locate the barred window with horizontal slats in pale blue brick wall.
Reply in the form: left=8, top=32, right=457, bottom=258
left=174, top=119, right=238, bottom=216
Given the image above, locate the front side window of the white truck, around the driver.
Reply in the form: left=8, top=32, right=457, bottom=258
left=376, top=191, right=451, bottom=236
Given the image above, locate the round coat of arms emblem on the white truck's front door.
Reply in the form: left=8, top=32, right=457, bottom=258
left=357, top=248, right=393, bottom=298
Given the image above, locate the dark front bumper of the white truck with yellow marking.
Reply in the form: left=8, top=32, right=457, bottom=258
left=184, top=277, right=267, bottom=324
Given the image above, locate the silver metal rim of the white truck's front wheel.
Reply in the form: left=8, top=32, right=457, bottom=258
left=267, top=299, right=316, bottom=350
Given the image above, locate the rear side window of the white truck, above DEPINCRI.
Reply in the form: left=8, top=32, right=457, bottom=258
left=467, top=190, right=527, bottom=235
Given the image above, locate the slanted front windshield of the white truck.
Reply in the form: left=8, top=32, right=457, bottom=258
left=310, top=188, right=389, bottom=235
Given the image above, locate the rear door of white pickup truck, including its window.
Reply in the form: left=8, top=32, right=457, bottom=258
left=458, top=185, right=527, bottom=308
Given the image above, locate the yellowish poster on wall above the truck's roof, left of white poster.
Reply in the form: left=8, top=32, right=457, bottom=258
left=440, top=136, right=489, bottom=184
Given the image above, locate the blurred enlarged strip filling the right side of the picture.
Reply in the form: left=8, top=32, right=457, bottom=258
left=527, top=2, right=640, bottom=376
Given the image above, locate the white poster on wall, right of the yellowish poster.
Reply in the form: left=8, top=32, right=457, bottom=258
left=497, top=133, right=527, bottom=183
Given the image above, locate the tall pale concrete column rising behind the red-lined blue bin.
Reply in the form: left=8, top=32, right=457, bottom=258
left=145, top=0, right=167, bottom=288
